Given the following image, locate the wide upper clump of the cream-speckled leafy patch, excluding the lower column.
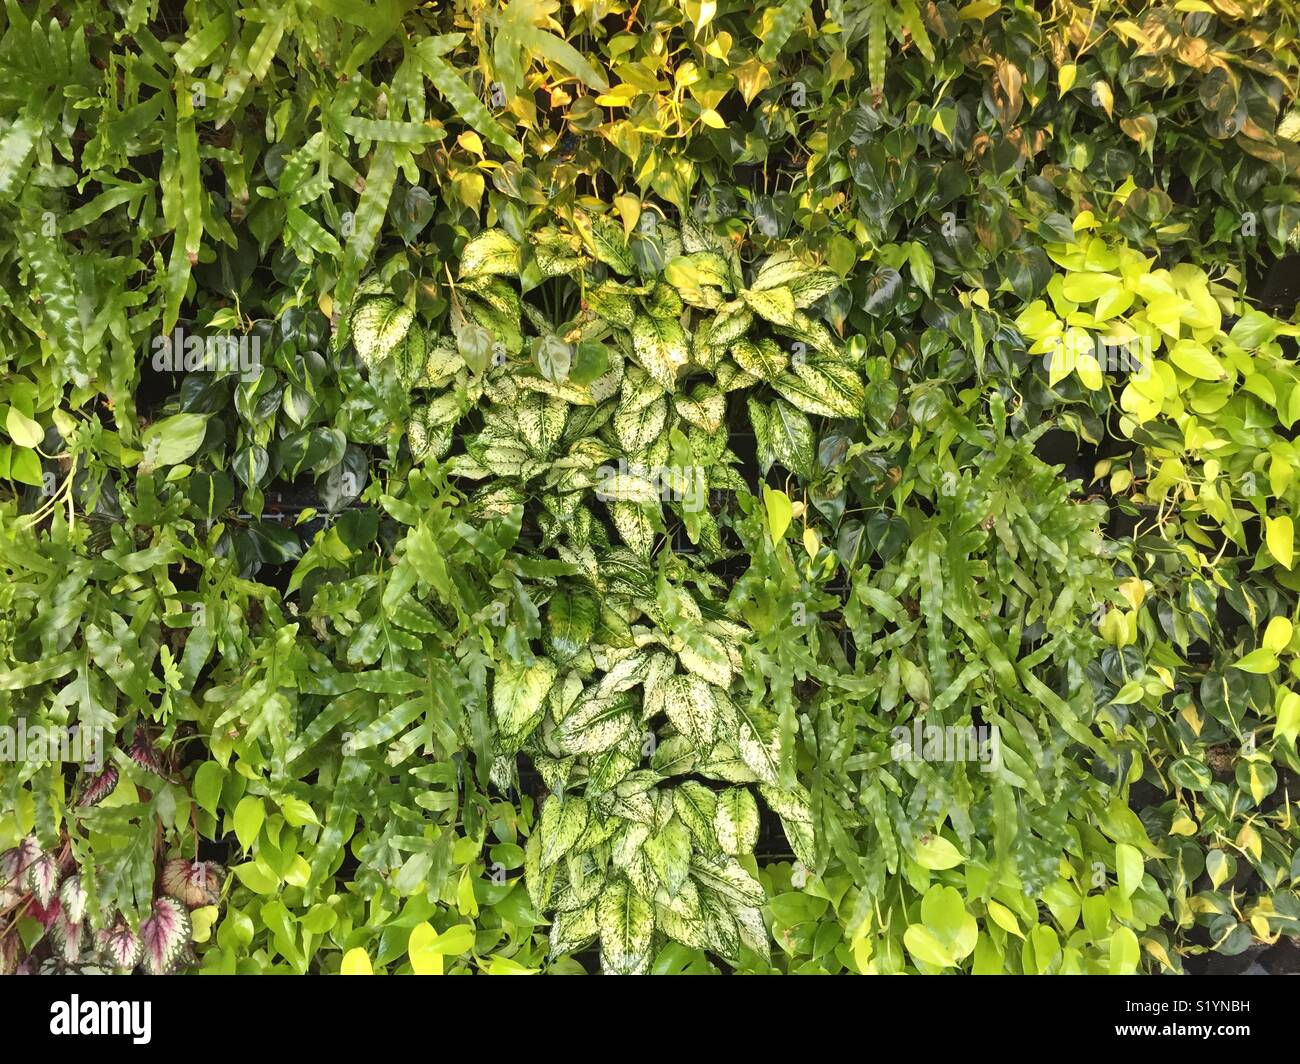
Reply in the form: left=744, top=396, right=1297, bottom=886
left=351, top=209, right=847, bottom=556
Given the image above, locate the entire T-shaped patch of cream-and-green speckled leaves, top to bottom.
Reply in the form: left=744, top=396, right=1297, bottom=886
left=350, top=209, right=832, bottom=972
